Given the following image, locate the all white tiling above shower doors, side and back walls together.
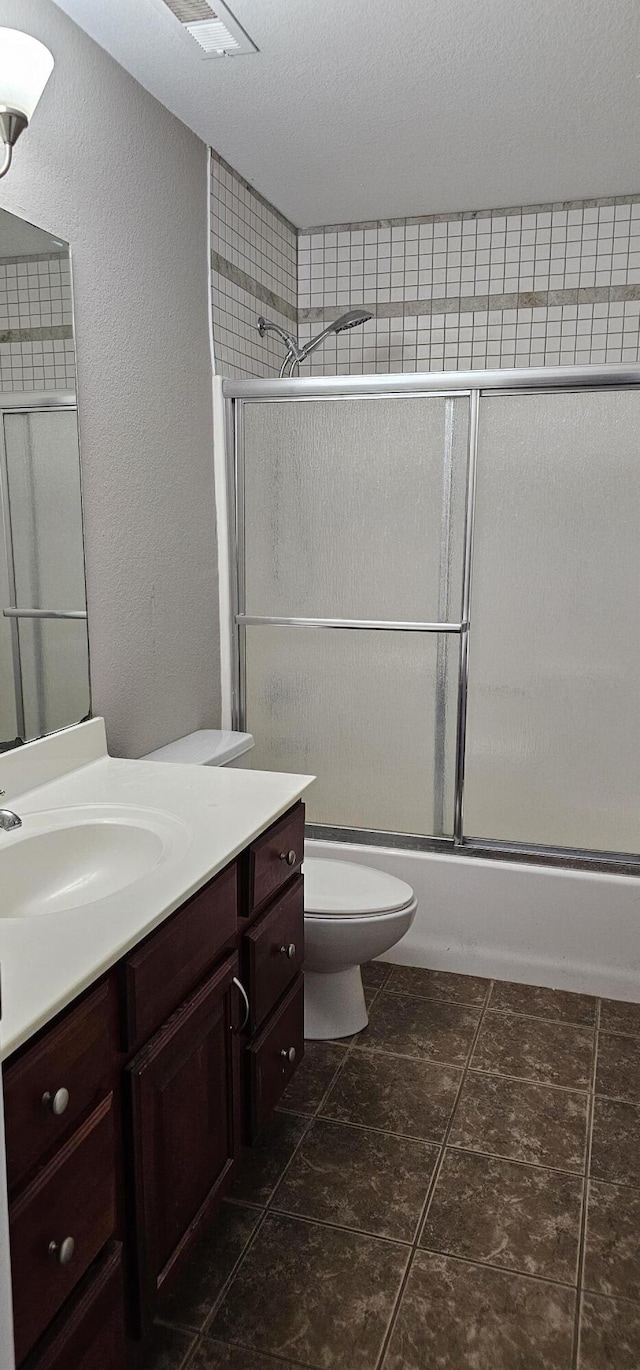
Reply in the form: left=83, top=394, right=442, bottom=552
left=211, top=166, right=640, bottom=377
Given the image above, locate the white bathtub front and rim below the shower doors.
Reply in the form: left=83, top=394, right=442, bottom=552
left=306, top=840, right=640, bottom=1003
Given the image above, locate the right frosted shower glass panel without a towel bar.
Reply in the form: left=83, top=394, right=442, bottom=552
left=465, top=390, right=640, bottom=852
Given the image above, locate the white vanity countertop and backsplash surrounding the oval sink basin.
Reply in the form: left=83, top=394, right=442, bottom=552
left=0, top=721, right=312, bottom=1059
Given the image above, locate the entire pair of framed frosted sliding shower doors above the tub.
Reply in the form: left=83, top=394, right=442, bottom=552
left=225, top=367, right=640, bottom=859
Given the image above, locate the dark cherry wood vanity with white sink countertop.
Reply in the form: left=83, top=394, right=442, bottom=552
left=0, top=721, right=308, bottom=1370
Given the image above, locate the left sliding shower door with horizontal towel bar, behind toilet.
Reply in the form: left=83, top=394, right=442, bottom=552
left=237, top=393, right=470, bottom=836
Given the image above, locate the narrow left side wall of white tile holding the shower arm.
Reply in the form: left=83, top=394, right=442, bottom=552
left=211, top=153, right=297, bottom=377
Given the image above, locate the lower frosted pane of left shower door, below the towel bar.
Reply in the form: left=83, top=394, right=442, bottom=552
left=245, top=626, right=458, bottom=834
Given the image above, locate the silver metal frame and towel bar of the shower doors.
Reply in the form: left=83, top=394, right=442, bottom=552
left=222, top=363, right=640, bottom=874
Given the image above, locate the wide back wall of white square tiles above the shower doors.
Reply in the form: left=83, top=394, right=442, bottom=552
left=299, top=196, right=640, bottom=374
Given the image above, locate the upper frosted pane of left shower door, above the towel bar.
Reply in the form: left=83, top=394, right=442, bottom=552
left=243, top=396, right=469, bottom=622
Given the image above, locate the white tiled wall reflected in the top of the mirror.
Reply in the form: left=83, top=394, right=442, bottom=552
left=0, top=255, right=75, bottom=390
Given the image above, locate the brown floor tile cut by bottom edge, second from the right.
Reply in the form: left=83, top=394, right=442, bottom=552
left=384, top=1251, right=574, bottom=1370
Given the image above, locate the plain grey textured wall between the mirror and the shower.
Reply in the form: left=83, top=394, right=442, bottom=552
left=0, top=0, right=219, bottom=756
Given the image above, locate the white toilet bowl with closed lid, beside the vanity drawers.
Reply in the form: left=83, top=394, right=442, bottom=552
left=303, top=856, right=417, bottom=1040
